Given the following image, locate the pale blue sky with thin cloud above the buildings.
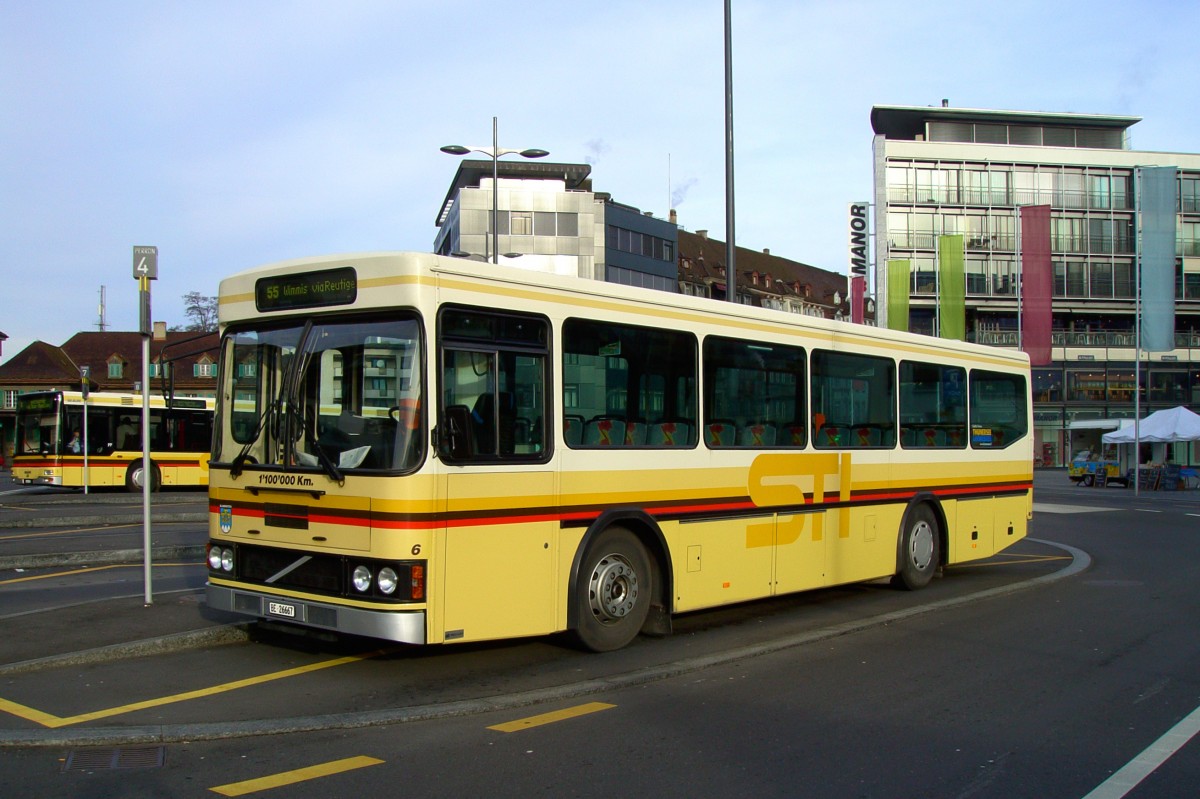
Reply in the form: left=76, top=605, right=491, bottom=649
left=0, top=0, right=1200, bottom=360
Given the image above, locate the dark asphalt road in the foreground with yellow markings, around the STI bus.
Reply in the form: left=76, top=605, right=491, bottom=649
left=0, top=473, right=1200, bottom=799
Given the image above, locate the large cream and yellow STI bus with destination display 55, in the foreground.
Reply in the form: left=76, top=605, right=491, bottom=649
left=208, top=253, right=1033, bottom=651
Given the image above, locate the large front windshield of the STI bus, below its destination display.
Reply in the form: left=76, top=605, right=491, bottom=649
left=212, top=313, right=425, bottom=479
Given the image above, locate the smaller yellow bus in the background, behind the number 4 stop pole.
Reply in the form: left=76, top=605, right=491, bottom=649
left=12, top=391, right=216, bottom=492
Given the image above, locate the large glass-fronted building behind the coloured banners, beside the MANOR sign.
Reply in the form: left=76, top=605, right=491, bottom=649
left=871, top=103, right=1200, bottom=467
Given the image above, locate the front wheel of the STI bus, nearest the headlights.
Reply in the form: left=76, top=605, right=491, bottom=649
left=571, top=527, right=654, bottom=651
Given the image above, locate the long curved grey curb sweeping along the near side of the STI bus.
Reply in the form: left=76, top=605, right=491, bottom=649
left=0, top=539, right=1092, bottom=747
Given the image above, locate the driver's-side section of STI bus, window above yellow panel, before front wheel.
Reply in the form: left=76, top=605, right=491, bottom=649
left=430, top=311, right=559, bottom=641
